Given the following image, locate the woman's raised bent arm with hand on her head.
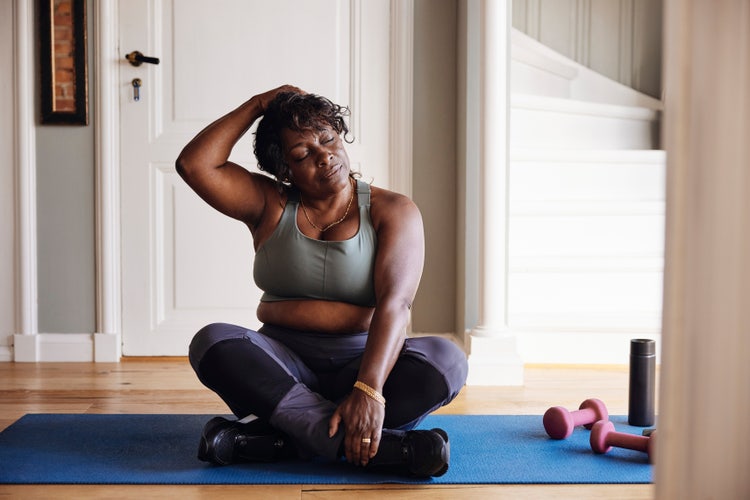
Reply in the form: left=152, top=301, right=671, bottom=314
left=176, top=85, right=301, bottom=228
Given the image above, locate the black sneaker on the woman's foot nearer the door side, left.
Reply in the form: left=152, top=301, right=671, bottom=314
left=198, top=417, right=296, bottom=465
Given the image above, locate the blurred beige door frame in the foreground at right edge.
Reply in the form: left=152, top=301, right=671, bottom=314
left=655, top=0, right=750, bottom=499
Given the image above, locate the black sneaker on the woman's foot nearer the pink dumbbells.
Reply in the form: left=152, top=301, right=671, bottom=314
left=367, top=429, right=450, bottom=477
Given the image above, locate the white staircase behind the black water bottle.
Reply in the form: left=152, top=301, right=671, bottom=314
left=508, top=30, right=666, bottom=364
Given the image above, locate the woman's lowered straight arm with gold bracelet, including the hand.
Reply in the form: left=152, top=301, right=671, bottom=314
left=330, top=188, right=424, bottom=465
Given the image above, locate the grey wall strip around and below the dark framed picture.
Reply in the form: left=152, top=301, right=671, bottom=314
left=36, top=0, right=96, bottom=333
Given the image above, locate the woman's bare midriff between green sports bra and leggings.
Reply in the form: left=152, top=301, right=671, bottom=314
left=258, top=300, right=375, bottom=335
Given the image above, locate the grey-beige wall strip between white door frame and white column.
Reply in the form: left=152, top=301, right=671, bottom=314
left=412, top=0, right=458, bottom=333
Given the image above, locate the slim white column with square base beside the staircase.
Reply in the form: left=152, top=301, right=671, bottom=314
left=468, top=0, right=523, bottom=385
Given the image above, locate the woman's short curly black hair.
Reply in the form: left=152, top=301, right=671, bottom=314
left=253, top=92, right=351, bottom=184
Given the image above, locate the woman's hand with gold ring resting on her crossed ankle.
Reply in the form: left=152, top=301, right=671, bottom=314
left=328, top=389, right=385, bottom=466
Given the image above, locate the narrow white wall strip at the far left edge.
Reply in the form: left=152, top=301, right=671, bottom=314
left=0, top=0, right=16, bottom=361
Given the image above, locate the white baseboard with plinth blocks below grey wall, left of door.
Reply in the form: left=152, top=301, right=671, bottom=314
left=11, top=333, right=121, bottom=363
